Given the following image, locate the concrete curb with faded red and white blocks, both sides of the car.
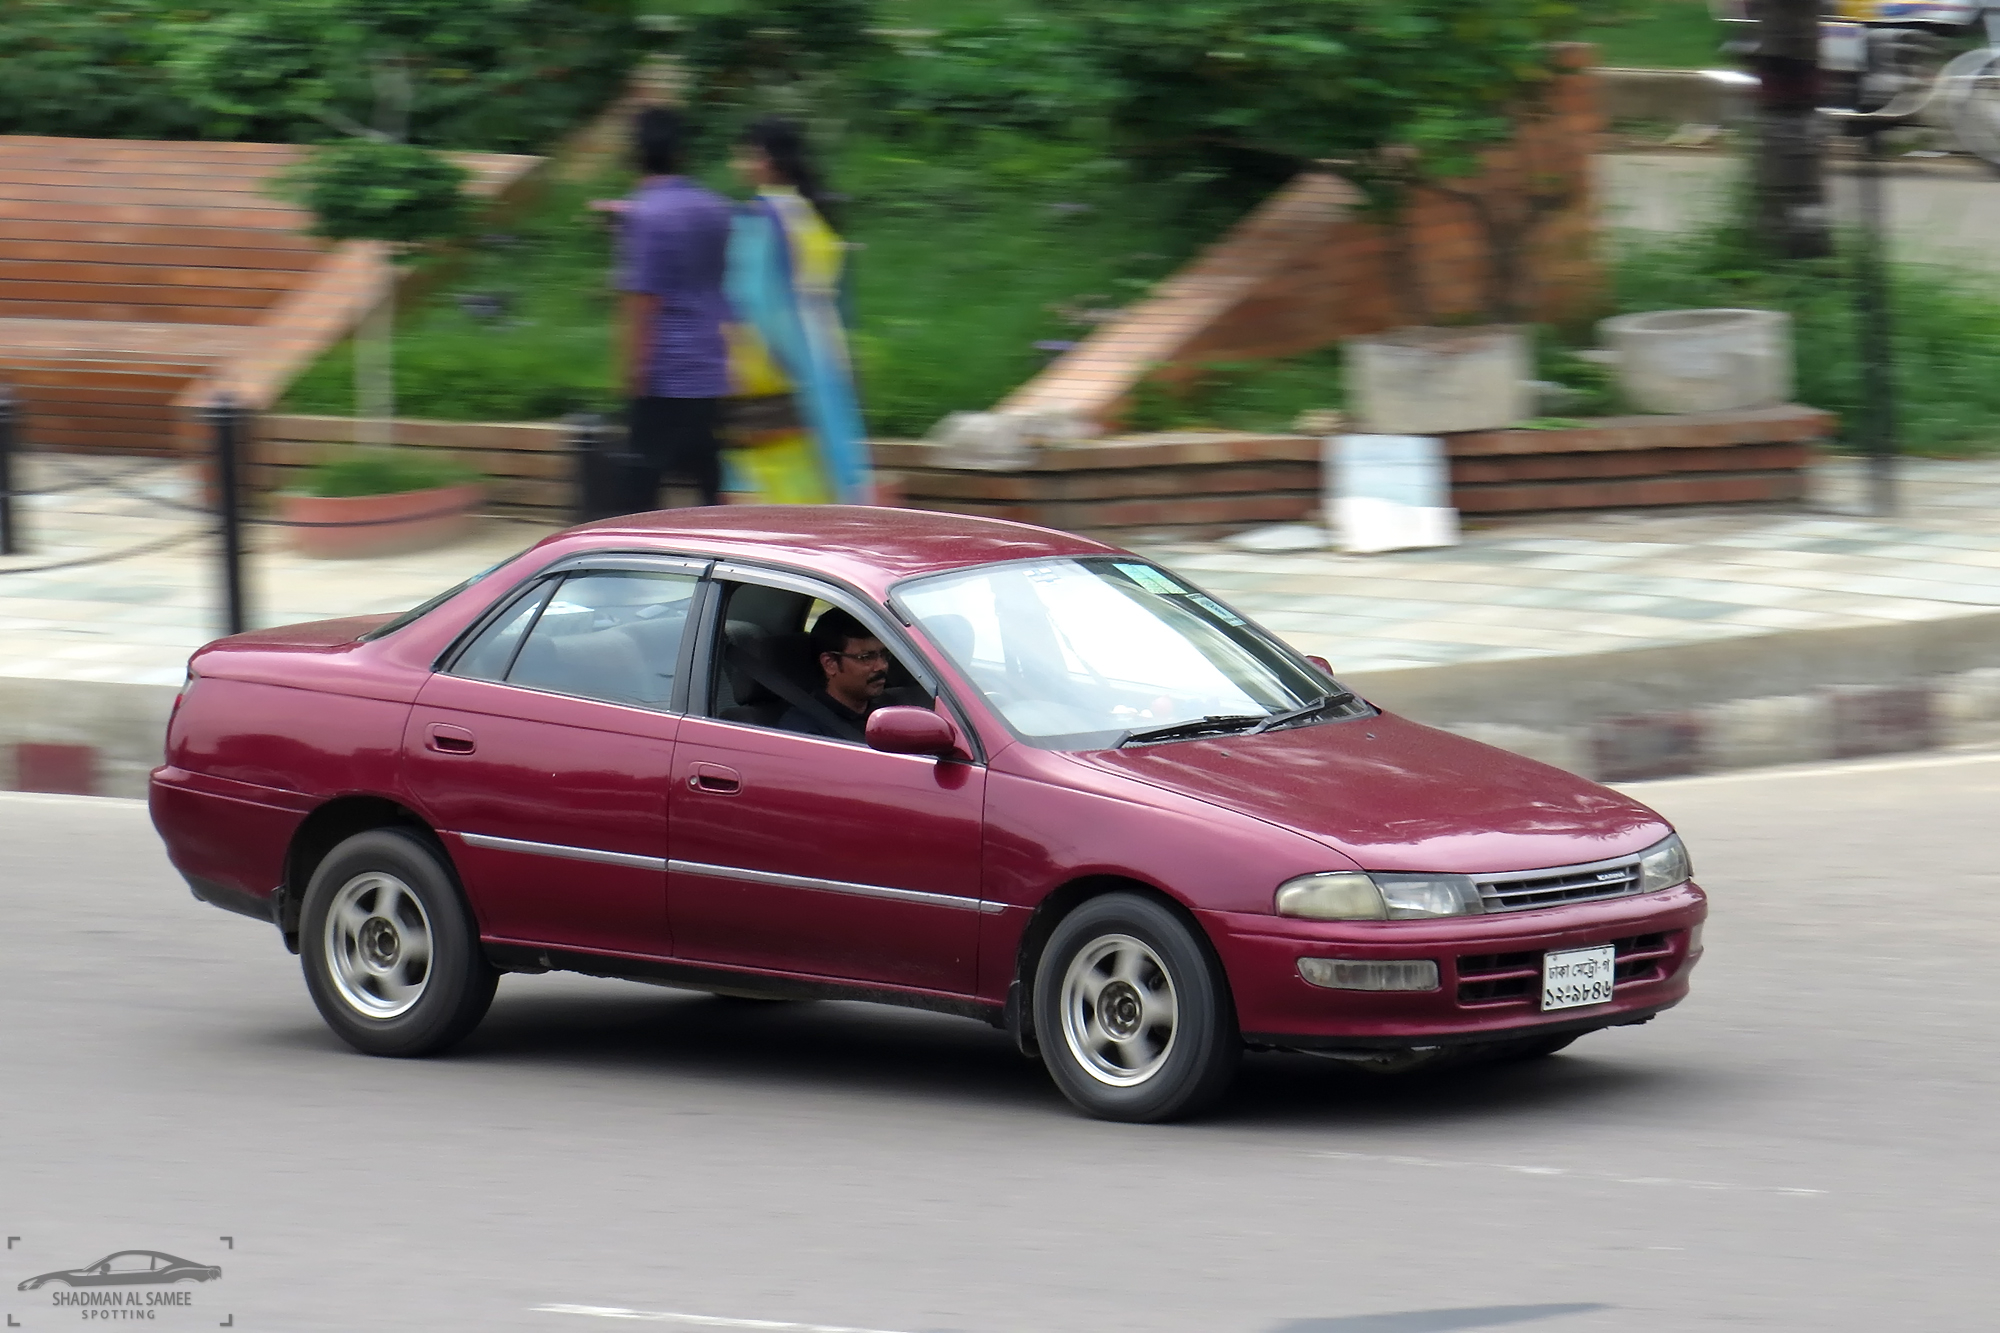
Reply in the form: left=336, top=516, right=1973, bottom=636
left=11, top=612, right=2000, bottom=799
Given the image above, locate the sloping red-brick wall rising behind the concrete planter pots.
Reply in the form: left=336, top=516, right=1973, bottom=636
left=1002, top=46, right=1604, bottom=420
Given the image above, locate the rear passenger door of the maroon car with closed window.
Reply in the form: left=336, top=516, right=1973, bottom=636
left=404, top=556, right=706, bottom=957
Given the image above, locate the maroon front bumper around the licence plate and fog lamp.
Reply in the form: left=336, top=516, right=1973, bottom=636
left=1196, top=883, right=1708, bottom=1049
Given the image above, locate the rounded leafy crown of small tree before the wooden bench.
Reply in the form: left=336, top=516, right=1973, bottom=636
left=280, top=138, right=470, bottom=244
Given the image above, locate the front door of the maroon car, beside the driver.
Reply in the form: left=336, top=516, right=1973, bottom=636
left=668, top=566, right=986, bottom=993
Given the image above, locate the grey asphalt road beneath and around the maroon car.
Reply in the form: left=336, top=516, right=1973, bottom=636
left=0, top=755, right=2000, bottom=1333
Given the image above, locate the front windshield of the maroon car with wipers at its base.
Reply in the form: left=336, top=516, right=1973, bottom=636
left=896, top=556, right=1366, bottom=751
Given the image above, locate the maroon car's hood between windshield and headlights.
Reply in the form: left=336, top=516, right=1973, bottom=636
left=1074, top=715, right=1670, bottom=873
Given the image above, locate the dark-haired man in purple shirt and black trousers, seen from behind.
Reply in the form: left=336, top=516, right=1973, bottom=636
left=618, top=106, right=732, bottom=512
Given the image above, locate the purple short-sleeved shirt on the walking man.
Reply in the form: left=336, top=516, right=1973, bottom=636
left=618, top=176, right=734, bottom=398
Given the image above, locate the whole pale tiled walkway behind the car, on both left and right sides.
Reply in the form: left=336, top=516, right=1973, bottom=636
left=0, top=458, right=2000, bottom=685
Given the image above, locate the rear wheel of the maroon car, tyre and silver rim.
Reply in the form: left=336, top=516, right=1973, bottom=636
left=298, top=829, right=498, bottom=1057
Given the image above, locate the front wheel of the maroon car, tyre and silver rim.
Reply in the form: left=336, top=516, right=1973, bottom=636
left=1034, top=893, right=1242, bottom=1123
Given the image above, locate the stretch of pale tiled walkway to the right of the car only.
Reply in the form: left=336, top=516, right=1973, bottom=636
left=1148, top=460, right=2000, bottom=671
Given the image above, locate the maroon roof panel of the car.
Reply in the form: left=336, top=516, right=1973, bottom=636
left=542, top=504, right=1118, bottom=588
